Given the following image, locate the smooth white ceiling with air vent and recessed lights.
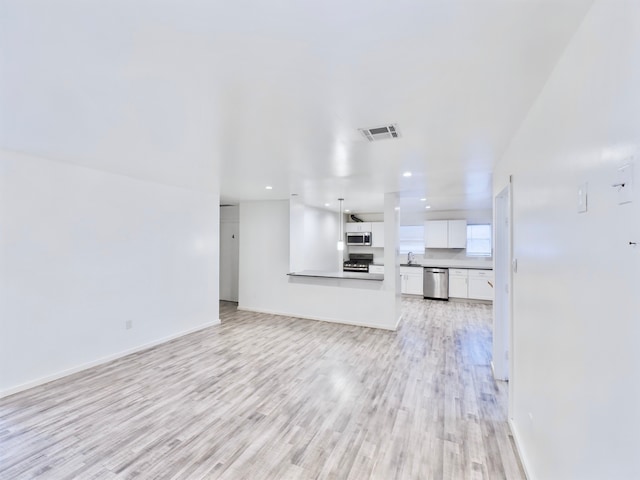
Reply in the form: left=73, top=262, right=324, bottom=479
left=0, top=0, right=592, bottom=213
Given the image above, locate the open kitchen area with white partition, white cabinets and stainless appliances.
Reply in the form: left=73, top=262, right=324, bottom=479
left=229, top=194, right=493, bottom=330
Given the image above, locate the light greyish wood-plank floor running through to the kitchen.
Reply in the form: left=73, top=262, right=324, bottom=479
left=0, top=298, right=524, bottom=480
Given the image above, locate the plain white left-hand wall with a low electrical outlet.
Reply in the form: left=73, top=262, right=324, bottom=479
left=0, top=151, right=219, bottom=395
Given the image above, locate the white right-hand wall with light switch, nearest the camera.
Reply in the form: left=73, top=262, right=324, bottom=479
left=494, top=1, right=640, bottom=480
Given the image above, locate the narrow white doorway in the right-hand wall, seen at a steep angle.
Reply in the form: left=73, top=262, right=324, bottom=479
left=492, top=184, right=512, bottom=381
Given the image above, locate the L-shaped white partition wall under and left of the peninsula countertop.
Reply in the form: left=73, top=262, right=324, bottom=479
left=239, top=201, right=399, bottom=329
